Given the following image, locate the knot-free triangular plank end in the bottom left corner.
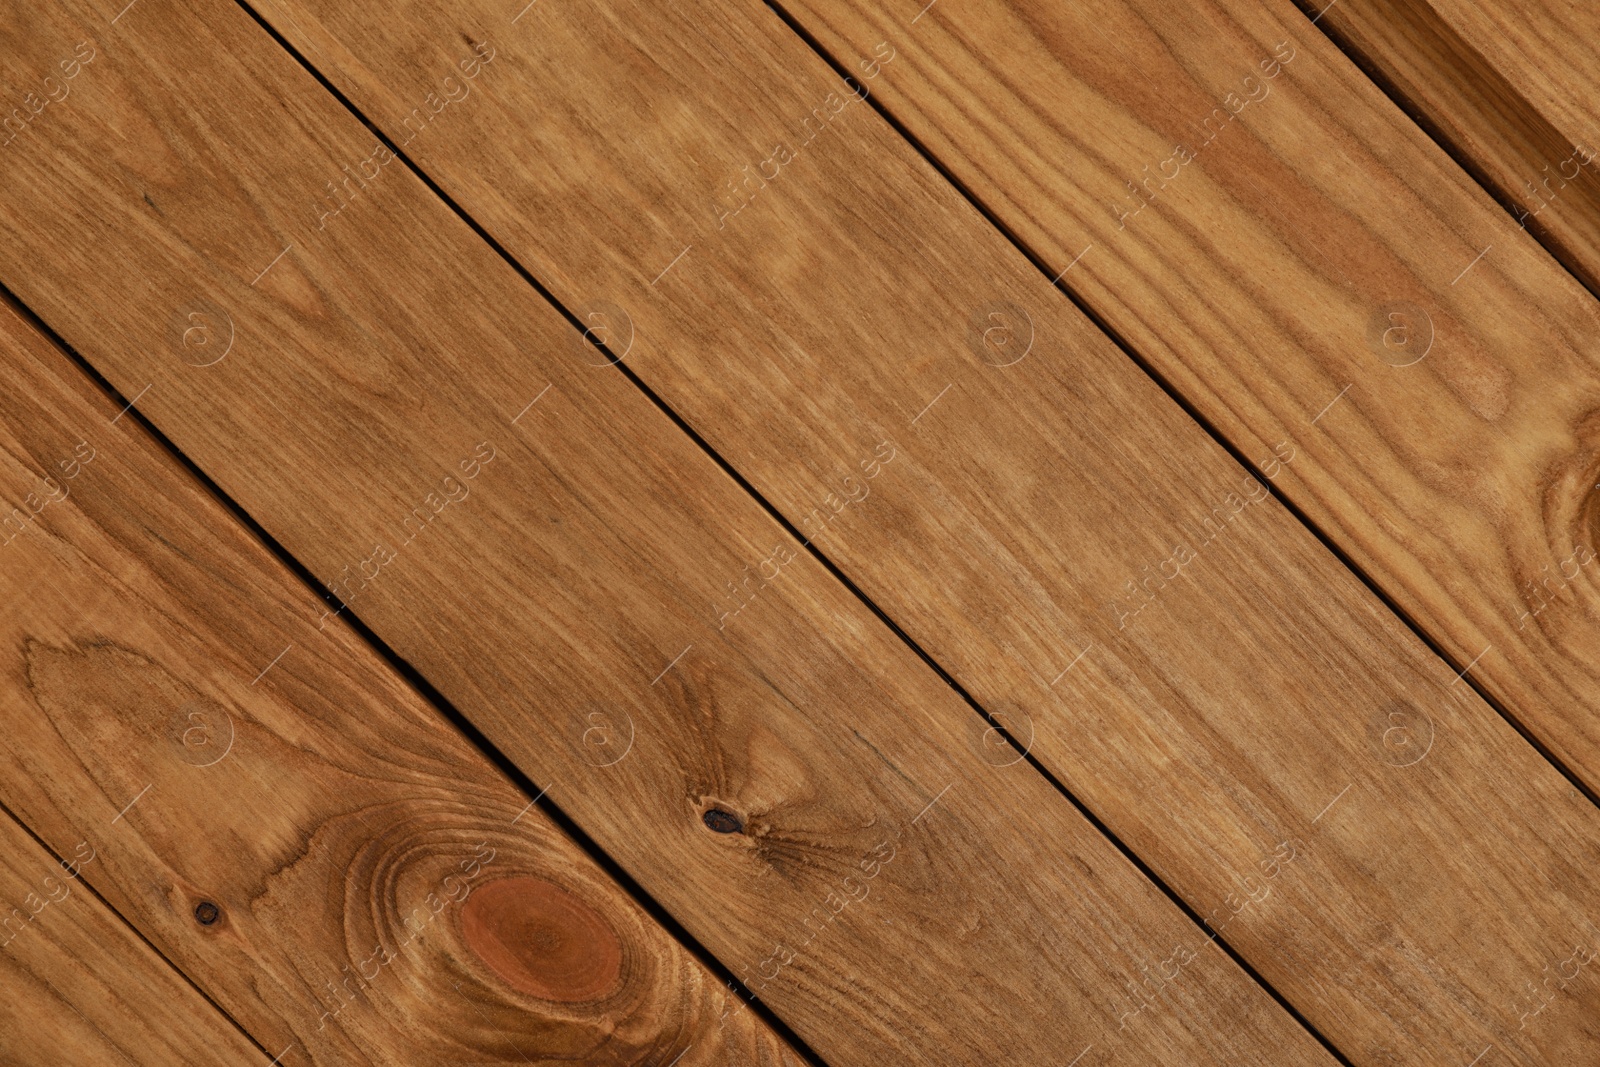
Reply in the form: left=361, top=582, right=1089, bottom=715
left=0, top=811, right=269, bottom=1067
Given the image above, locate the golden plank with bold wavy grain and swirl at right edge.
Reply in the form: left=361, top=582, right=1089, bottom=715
left=774, top=0, right=1600, bottom=809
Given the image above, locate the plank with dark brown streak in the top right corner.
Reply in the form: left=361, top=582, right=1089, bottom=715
left=1302, top=0, right=1600, bottom=294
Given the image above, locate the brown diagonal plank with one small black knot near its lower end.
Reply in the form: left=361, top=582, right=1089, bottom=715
left=0, top=0, right=1330, bottom=1067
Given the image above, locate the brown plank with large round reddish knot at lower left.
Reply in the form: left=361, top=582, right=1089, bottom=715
left=0, top=307, right=802, bottom=1067
